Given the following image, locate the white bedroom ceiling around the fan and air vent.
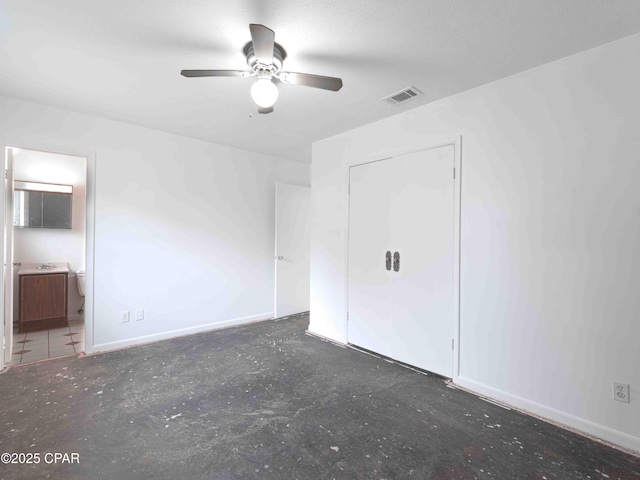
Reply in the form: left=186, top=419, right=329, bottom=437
left=0, top=0, right=640, bottom=162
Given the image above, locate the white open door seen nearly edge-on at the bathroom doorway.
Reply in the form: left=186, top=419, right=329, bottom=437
left=2, top=147, right=13, bottom=365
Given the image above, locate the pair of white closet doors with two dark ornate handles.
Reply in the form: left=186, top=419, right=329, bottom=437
left=348, top=146, right=454, bottom=377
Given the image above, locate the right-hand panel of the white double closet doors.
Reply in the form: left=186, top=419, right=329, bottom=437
left=389, top=146, right=454, bottom=377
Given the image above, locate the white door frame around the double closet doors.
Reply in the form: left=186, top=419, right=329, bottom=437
left=343, top=136, right=462, bottom=383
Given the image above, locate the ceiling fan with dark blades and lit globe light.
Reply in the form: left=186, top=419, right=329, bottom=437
left=180, top=23, right=342, bottom=113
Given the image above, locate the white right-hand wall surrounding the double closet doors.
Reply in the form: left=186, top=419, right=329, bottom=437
left=310, top=31, right=640, bottom=450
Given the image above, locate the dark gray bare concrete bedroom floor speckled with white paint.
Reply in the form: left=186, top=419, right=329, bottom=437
left=0, top=315, right=640, bottom=480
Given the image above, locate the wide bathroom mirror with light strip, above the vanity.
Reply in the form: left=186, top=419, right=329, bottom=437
left=13, top=180, right=73, bottom=229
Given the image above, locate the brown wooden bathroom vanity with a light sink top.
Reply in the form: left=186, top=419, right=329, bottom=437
left=18, top=263, right=69, bottom=333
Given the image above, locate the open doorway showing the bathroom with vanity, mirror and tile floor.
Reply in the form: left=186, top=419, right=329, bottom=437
left=4, top=147, right=88, bottom=366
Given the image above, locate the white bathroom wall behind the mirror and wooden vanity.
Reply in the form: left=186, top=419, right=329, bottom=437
left=13, top=149, right=87, bottom=322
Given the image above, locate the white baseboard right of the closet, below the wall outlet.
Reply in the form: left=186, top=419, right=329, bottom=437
left=454, top=377, right=640, bottom=454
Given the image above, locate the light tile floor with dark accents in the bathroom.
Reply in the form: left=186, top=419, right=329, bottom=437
left=11, top=320, right=84, bottom=365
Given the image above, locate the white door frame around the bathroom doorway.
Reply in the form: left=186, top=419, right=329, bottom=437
left=0, top=138, right=96, bottom=372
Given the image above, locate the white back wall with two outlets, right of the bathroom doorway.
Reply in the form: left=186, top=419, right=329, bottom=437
left=0, top=97, right=309, bottom=350
